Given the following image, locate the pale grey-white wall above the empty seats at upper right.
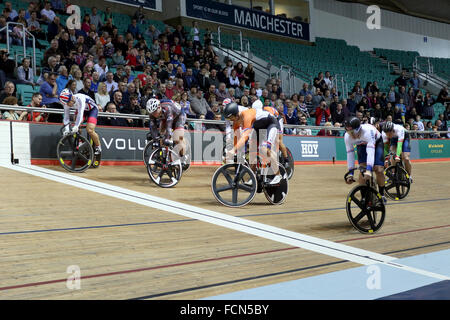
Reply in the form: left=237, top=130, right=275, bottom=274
left=310, top=0, right=450, bottom=58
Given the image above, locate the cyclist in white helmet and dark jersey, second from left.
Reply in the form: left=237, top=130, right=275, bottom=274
left=146, top=98, right=188, bottom=170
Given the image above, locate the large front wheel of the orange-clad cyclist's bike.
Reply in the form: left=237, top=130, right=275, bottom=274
left=211, top=163, right=257, bottom=208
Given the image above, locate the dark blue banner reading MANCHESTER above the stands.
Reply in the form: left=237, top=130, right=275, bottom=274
left=186, top=0, right=309, bottom=41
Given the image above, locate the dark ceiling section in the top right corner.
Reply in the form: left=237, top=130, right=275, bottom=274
left=338, top=0, right=450, bottom=24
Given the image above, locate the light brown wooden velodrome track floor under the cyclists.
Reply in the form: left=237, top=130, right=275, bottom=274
left=0, top=162, right=450, bottom=299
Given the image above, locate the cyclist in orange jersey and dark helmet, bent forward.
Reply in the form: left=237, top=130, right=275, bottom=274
left=223, top=102, right=282, bottom=185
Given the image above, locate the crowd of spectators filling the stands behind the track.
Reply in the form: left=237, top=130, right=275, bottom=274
left=0, top=0, right=450, bottom=137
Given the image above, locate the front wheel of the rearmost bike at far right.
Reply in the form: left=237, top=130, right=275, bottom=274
left=384, top=166, right=411, bottom=200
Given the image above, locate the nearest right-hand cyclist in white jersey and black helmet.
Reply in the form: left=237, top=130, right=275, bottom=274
left=344, top=117, right=387, bottom=203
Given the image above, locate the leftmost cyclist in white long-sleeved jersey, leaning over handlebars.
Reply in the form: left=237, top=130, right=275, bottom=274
left=59, top=88, right=102, bottom=156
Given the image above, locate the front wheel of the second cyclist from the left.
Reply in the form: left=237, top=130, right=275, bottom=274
left=147, top=148, right=183, bottom=188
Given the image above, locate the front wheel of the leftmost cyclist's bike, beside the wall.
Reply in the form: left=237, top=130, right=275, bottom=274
left=56, top=134, right=94, bottom=172
